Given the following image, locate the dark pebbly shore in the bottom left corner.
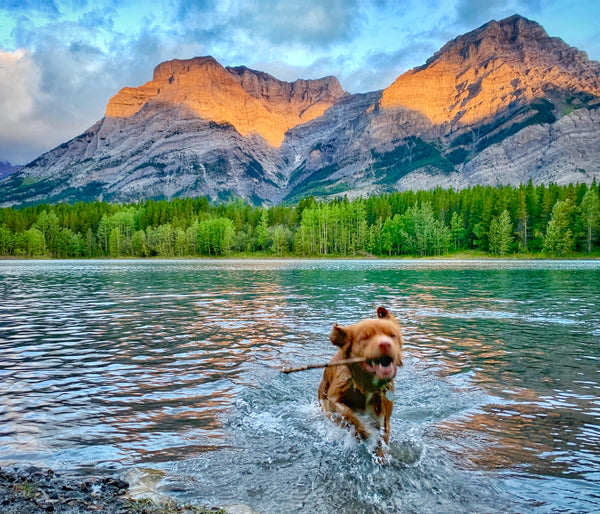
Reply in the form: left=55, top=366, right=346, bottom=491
left=0, top=467, right=226, bottom=514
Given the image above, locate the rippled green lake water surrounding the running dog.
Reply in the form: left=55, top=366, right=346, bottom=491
left=0, top=260, right=600, bottom=513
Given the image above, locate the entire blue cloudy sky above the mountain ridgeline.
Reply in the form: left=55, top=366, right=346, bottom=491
left=0, top=0, right=600, bottom=164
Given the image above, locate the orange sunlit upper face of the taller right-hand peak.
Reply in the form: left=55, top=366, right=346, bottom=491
left=380, top=16, right=600, bottom=130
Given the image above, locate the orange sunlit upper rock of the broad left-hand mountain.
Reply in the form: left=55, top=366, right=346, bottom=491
left=106, top=57, right=346, bottom=147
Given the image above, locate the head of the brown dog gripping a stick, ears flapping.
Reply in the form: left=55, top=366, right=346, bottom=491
left=329, top=307, right=402, bottom=384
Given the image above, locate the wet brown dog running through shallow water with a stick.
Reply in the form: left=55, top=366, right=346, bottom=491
left=319, top=307, right=402, bottom=455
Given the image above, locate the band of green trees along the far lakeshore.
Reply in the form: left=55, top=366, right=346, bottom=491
left=0, top=182, right=600, bottom=258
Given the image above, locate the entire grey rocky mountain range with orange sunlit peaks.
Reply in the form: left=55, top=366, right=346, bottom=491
left=0, top=15, right=600, bottom=205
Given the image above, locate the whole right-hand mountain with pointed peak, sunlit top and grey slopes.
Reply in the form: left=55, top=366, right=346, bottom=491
left=291, top=16, right=600, bottom=198
